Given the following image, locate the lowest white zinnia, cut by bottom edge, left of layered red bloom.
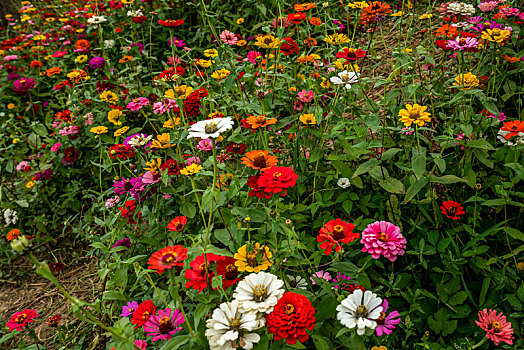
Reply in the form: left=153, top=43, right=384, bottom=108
left=205, top=300, right=265, bottom=350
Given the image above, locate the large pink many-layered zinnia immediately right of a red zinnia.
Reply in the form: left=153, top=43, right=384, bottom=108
left=360, top=221, right=406, bottom=262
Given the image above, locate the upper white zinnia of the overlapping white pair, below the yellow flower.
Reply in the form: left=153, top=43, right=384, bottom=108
left=233, top=271, right=284, bottom=313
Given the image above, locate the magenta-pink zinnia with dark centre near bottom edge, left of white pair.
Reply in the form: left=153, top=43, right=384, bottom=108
left=144, top=308, right=185, bottom=341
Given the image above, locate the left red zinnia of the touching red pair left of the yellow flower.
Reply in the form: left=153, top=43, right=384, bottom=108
left=184, top=253, right=224, bottom=293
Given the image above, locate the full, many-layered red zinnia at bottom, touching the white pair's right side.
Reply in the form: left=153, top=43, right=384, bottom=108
left=266, top=292, right=315, bottom=345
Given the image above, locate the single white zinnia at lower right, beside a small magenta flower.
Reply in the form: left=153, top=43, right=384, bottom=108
left=337, top=289, right=382, bottom=335
